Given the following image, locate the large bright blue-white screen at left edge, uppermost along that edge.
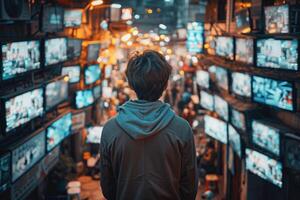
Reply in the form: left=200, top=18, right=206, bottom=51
left=0, top=40, right=41, bottom=80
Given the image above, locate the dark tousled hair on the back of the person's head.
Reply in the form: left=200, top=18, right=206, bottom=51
left=125, top=50, right=172, bottom=101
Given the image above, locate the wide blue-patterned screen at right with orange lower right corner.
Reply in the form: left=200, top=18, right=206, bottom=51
left=252, top=76, right=295, bottom=111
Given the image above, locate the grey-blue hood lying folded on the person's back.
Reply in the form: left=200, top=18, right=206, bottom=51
left=116, top=100, right=175, bottom=139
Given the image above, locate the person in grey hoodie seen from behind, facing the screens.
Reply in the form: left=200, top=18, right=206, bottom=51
left=100, top=50, right=198, bottom=200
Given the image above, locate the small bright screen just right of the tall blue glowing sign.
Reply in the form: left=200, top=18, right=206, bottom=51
left=216, top=36, right=234, bottom=60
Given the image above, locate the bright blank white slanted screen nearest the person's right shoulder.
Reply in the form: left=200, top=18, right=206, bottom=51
left=204, top=115, right=227, bottom=144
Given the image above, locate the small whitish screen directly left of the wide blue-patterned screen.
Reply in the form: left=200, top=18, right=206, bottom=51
left=231, top=72, right=251, bottom=97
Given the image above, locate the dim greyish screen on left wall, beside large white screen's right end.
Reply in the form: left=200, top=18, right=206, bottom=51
left=45, top=76, right=69, bottom=110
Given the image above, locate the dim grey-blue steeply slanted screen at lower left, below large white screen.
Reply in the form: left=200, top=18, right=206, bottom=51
left=11, top=130, right=46, bottom=182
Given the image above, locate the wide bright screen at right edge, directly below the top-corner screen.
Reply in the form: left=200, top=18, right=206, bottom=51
left=256, top=38, right=298, bottom=70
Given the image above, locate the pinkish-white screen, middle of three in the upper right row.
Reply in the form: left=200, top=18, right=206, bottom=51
left=235, top=38, right=254, bottom=64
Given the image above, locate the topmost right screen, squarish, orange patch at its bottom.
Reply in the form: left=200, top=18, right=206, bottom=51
left=264, top=4, right=289, bottom=33
